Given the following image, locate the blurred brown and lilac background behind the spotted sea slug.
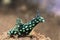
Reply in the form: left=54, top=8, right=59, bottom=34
left=0, top=0, right=60, bottom=40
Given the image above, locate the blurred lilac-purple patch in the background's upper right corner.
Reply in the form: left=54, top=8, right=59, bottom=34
left=39, top=0, right=60, bottom=14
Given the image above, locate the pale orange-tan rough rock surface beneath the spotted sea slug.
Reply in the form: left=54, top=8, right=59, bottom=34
left=0, top=32, right=51, bottom=40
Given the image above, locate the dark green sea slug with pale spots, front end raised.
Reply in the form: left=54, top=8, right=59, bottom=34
left=8, top=16, right=45, bottom=36
